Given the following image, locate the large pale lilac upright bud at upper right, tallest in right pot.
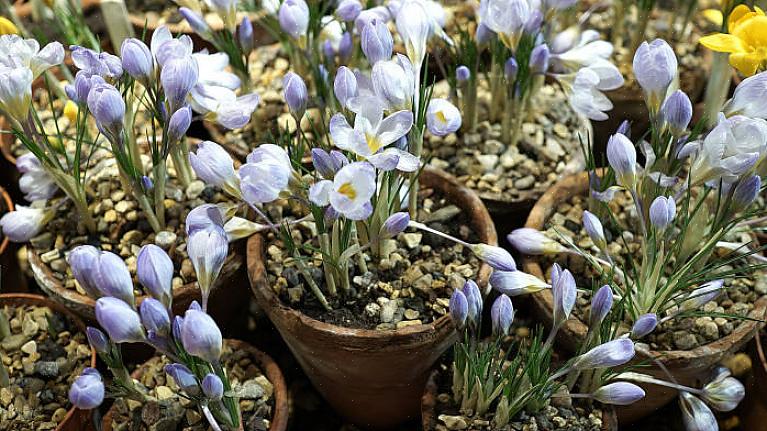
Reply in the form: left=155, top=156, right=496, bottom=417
left=633, top=39, right=677, bottom=113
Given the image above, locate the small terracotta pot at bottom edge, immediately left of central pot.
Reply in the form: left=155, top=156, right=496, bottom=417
left=102, top=339, right=290, bottom=431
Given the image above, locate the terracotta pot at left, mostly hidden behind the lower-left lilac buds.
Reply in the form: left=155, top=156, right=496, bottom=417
left=27, top=241, right=248, bottom=333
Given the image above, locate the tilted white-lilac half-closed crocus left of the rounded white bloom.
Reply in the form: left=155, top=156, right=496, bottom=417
left=189, top=141, right=240, bottom=196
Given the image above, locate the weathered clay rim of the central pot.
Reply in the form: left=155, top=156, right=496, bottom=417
left=246, top=166, right=498, bottom=344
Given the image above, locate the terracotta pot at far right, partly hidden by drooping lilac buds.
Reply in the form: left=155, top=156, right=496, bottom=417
left=523, top=173, right=767, bottom=424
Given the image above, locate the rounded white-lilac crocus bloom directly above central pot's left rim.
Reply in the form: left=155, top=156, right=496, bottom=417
left=238, top=144, right=293, bottom=205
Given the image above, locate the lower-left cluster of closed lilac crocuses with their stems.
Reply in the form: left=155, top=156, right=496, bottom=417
left=67, top=205, right=240, bottom=429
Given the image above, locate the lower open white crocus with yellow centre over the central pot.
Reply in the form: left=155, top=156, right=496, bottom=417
left=309, top=162, right=376, bottom=220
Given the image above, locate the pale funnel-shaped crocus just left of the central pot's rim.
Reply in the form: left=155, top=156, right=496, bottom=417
left=186, top=223, right=229, bottom=309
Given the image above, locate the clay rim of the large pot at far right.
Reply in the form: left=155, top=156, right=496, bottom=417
left=522, top=172, right=767, bottom=365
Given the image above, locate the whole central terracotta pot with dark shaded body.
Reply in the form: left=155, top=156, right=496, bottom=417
left=247, top=168, right=497, bottom=428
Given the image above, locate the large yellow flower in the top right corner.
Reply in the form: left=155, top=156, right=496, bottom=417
left=700, top=5, right=767, bottom=76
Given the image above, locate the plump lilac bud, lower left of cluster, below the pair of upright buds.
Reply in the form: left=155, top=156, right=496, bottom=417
left=96, top=296, right=146, bottom=343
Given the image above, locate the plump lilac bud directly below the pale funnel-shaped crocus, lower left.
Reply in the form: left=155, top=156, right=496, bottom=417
left=181, top=310, right=223, bottom=364
